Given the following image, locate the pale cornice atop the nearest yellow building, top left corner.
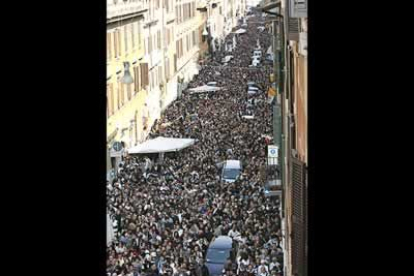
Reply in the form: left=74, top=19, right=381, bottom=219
left=106, top=0, right=148, bottom=23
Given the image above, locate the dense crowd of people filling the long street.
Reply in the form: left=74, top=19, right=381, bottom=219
left=107, top=12, right=283, bottom=276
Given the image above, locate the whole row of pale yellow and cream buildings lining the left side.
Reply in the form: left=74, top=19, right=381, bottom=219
left=106, top=0, right=246, bottom=170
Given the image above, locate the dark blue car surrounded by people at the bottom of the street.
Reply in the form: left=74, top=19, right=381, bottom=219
left=206, top=236, right=237, bottom=276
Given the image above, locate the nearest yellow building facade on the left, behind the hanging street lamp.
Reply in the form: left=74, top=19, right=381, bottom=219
left=106, top=0, right=148, bottom=163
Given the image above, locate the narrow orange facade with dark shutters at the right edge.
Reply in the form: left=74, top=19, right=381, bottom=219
left=282, top=0, right=308, bottom=276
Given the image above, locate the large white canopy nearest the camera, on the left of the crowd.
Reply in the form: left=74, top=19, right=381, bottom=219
left=128, top=136, right=196, bottom=154
